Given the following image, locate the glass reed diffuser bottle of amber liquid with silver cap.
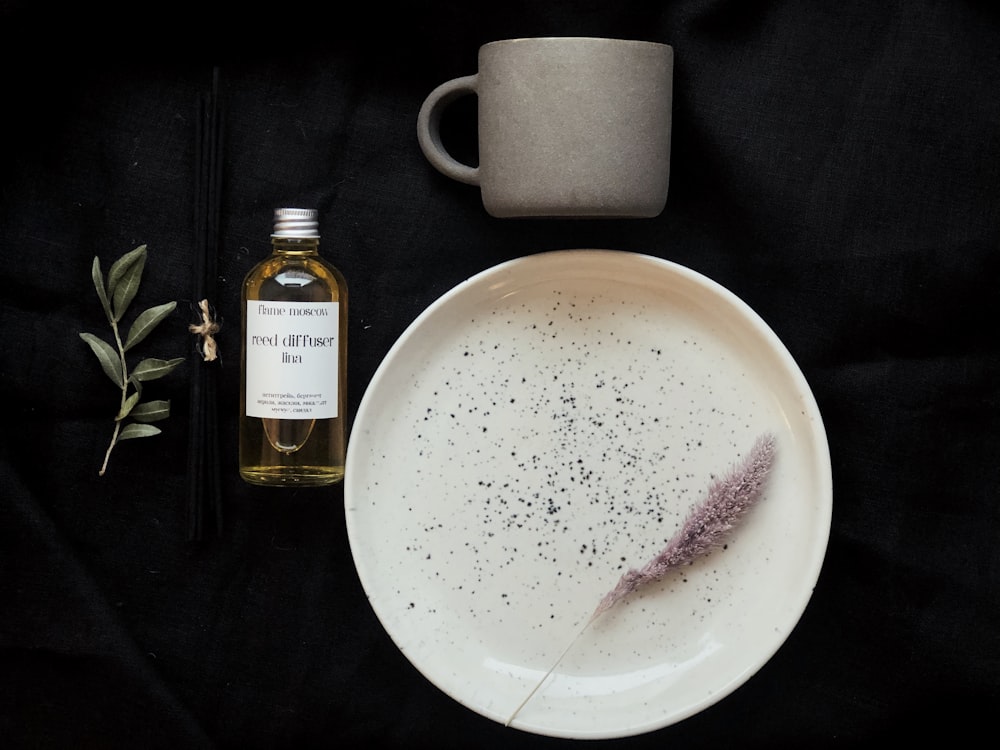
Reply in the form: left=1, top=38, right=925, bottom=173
left=239, top=209, right=347, bottom=487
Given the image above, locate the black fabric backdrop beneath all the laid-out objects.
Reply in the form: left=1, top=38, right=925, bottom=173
left=0, top=0, right=1000, bottom=748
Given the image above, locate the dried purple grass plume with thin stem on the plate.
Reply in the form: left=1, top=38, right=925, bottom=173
left=506, top=434, right=775, bottom=726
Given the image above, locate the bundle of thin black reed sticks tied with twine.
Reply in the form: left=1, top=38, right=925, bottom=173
left=187, top=68, right=223, bottom=541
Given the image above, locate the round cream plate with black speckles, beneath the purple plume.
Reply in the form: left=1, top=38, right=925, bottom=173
left=345, top=250, right=832, bottom=738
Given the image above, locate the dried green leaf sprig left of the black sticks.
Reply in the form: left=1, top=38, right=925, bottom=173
left=80, top=245, right=184, bottom=476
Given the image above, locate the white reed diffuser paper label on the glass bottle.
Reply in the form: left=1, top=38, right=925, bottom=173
left=246, top=300, right=340, bottom=419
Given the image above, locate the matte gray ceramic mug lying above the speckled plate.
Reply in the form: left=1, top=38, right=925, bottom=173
left=417, top=37, right=673, bottom=218
